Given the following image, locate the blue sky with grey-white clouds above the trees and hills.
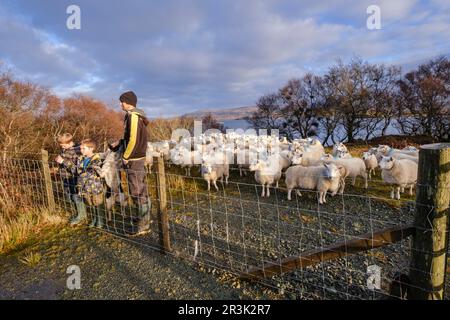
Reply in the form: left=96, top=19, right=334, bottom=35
left=0, top=0, right=450, bottom=117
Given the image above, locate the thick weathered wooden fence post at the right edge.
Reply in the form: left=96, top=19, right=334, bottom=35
left=408, top=143, right=450, bottom=300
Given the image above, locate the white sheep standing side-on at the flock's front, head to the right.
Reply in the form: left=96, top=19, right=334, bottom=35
left=286, top=164, right=341, bottom=204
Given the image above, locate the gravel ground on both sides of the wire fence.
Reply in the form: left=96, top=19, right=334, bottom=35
left=0, top=165, right=450, bottom=299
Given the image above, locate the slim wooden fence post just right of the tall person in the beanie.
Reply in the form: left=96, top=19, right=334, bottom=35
left=156, top=157, right=171, bottom=252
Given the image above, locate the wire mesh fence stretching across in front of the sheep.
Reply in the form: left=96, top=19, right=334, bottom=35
left=0, top=148, right=450, bottom=299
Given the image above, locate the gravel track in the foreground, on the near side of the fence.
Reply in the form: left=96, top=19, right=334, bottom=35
left=0, top=227, right=281, bottom=299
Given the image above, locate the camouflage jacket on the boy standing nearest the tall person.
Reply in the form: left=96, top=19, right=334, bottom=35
left=63, top=153, right=103, bottom=196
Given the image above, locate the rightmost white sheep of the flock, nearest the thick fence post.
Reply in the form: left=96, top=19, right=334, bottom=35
left=380, top=157, right=418, bottom=200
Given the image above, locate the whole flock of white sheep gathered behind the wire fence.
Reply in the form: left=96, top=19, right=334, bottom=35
left=104, top=133, right=419, bottom=204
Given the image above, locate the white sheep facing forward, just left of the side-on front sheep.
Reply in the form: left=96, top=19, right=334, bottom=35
left=250, top=158, right=282, bottom=198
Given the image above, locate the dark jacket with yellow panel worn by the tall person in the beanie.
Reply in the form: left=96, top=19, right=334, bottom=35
left=123, top=109, right=148, bottom=161
